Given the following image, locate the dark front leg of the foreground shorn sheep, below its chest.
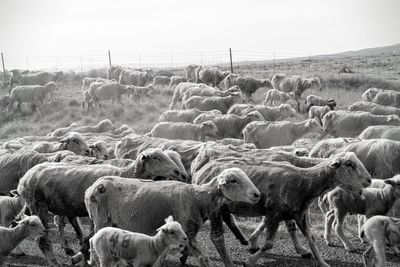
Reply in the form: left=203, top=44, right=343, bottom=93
left=210, top=211, right=234, bottom=267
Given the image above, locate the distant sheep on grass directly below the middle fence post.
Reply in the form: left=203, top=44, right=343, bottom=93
left=88, top=82, right=129, bottom=108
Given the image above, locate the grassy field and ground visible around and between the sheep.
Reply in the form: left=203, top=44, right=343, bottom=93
left=0, top=55, right=400, bottom=266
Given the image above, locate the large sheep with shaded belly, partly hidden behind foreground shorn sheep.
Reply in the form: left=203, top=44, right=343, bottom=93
left=17, top=149, right=186, bottom=266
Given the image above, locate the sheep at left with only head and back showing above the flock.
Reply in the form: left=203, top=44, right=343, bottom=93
left=32, top=132, right=90, bottom=156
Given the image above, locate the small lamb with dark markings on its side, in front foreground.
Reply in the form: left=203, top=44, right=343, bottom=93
left=89, top=216, right=187, bottom=267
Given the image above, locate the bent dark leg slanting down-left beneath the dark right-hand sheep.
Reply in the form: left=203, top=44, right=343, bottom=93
left=243, top=217, right=279, bottom=267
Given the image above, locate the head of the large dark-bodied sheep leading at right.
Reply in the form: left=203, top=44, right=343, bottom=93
left=329, top=152, right=371, bottom=193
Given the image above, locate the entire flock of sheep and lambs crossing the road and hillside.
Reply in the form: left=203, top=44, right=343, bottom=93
left=0, top=65, right=400, bottom=266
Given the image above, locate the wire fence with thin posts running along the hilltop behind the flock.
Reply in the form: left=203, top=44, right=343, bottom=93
left=0, top=49, right=400, bottom=79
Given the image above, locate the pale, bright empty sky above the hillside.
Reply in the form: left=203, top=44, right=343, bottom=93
left=0, top=0, right=400, bottom=69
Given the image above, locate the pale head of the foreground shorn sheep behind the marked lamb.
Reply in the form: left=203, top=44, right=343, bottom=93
left=217, top=168, right=260, bottom=204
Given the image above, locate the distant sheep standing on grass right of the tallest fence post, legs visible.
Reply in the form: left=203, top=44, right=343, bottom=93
left=271, top=73, right=322, bottom=111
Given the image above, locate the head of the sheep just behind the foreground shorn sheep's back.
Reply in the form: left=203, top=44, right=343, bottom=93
left=140, top=149, right=186, bottom=182
